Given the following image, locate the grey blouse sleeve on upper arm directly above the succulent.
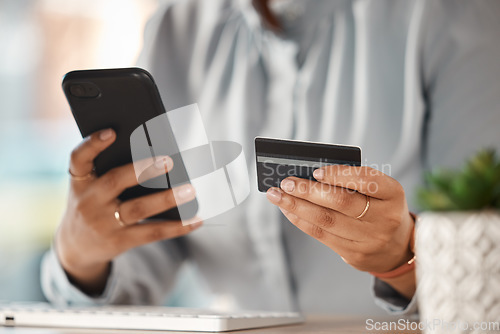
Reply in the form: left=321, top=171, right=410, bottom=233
left=422, top=0, right=500, bottom=169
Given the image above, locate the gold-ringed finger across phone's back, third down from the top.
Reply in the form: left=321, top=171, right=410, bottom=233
left=120, top=184, right=195, bottom=225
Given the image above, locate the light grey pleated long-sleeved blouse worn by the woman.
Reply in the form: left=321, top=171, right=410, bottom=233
left=42, top=0, right=500, bottom=314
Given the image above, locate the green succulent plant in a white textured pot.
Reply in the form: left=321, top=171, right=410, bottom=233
left=415, top=150, right=500, bottom=333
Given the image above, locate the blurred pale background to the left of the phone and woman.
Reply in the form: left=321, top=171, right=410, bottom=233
left=0, top=0, right=203, bottom=303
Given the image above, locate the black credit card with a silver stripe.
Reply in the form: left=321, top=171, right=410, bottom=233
left=255, top=137, right=361, bottom=192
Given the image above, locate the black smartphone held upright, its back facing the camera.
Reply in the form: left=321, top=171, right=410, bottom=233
left=62, top=68, right=198, bottom=220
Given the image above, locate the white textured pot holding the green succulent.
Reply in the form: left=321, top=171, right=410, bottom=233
left=415, top=211, right=500, bottom=334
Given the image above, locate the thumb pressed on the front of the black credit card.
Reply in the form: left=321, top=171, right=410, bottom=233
left=313, top=165, right=404, bottom=199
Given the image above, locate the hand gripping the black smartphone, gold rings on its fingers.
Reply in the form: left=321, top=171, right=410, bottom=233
left=55, top=129, right=201, bottom=294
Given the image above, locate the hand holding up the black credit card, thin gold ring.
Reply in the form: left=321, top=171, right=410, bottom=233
left=267, top=165, right=415, bottom=297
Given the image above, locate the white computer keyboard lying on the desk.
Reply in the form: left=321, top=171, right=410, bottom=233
left=0, top=303, right=303, bottom=332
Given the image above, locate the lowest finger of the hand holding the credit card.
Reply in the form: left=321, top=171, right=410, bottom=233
left=280, top=208, right=358, bottom=254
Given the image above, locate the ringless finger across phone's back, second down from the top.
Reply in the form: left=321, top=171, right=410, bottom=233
left=92, top=156, right=174, bottom=201
